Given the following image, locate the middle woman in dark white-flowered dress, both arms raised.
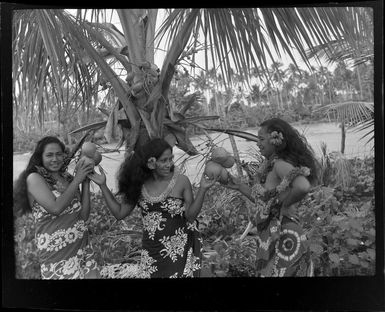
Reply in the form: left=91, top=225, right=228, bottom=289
left=90, top=139, right=215, bottom=278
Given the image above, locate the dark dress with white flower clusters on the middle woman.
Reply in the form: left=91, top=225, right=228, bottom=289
left=138, top=171, right=202, bottom=278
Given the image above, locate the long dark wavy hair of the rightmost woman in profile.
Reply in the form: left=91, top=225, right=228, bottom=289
left=260, top=118, right=319, bottom=185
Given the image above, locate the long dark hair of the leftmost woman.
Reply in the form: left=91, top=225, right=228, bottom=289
left=13, top=136, right=65, bottom=215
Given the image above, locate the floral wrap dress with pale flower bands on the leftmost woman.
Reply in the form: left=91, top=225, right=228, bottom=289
left=32, top=167, right=98, bottom=279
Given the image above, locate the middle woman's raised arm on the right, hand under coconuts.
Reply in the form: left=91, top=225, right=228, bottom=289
left=181, top=175, right=216, bottom=222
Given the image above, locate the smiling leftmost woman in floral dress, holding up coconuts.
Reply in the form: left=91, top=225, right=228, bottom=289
left=14, top=136, right=98, bottom=279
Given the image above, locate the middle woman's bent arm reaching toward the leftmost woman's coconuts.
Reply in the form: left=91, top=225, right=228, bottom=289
left=88, top=166, right=135, bottom=220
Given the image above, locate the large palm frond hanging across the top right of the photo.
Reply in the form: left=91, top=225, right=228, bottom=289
left=157, top=7, right=372, bottom=83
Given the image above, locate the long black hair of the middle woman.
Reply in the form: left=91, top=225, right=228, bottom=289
left=118, top=138, right=172, bottom=205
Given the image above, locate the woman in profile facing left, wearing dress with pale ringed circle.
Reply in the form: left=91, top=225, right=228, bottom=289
left=228, top=118, right=318, bottom=277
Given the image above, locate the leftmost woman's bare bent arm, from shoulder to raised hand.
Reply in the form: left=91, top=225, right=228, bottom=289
left=27, top=160, right=93, bottom=216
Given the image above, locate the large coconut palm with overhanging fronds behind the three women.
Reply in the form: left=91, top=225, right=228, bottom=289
left=13, top=7, right=372, bottom=154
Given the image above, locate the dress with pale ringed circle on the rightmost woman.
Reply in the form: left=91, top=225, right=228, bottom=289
left=252, top=160, right=313, bottom=277
